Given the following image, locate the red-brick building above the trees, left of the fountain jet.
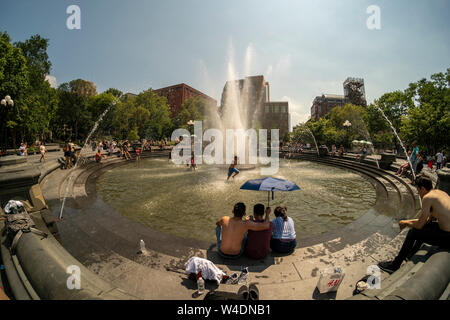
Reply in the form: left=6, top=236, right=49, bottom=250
left=155, top=83, right=217, bottom=117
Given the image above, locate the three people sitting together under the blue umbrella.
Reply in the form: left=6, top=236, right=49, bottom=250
left=216, top=202, right=297, bottom=259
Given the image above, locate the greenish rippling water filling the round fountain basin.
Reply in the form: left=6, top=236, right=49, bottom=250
left=96, top=159, right=376, bottom=242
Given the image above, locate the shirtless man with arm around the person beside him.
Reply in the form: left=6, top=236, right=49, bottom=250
left=216, top=202, right=270, bottom=258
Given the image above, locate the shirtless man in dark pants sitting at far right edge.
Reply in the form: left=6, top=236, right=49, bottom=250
left=378, top=177, right=450, bottom=273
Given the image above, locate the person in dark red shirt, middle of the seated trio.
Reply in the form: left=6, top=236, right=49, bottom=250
left=245, top=203, right=273, bottom=259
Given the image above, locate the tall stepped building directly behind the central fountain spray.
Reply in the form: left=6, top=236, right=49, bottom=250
left=220, top=75, right=290, bottom=138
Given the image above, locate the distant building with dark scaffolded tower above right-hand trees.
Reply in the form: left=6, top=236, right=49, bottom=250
left=311, top=77, right=367, bottom=121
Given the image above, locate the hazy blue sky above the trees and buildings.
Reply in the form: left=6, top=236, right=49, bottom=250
left=0, top=0, right=450, bottom=129
